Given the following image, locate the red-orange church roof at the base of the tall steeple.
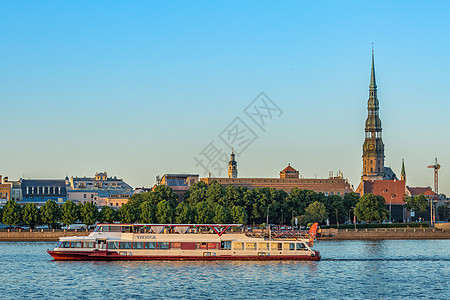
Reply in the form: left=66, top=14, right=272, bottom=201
left=358, top=180, right=406, bottom=205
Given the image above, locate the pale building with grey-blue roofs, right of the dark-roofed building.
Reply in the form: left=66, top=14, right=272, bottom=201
left=65, top=172, right=134, bottom=206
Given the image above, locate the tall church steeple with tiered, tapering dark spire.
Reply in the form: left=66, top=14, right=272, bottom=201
left=361, top=48, right=384, bottom=180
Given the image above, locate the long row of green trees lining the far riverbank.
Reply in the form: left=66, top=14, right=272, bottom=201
left=5, top=182, right=440, bottom=228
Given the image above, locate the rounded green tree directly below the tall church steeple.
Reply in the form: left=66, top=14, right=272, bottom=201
left=355, top=193, right=387, bottom=223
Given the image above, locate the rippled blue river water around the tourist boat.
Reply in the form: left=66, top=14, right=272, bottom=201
left=0, top=240, right=450, bottom=299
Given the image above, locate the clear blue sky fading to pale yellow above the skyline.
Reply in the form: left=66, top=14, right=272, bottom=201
left=0, top=1, right=450, bottom=195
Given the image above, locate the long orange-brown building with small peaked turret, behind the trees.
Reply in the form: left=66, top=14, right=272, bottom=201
left=200, top=165, right=353, bottom=197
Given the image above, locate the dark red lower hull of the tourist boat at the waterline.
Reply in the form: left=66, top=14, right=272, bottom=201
left=47, top=250, right=320, bottom=261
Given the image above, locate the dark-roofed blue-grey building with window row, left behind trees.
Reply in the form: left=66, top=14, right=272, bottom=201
left=21, top=179, right=67, bottom=205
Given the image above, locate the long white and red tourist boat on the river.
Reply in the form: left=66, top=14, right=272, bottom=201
left=47, top=223, right=320, bottom=261
